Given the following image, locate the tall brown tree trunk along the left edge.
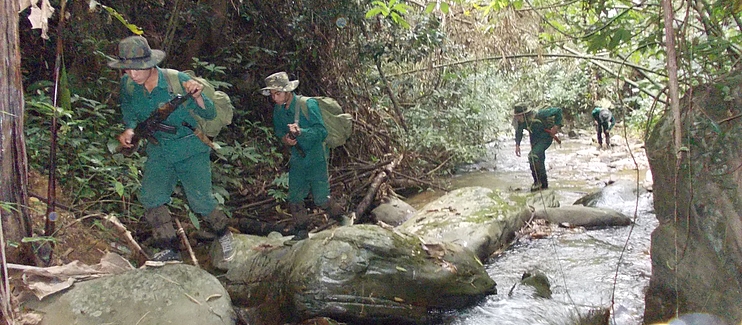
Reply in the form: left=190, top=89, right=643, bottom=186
left=0, top=0, right=33, bottom=263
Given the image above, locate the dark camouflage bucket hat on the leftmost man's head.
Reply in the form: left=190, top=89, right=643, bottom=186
left=108, top=36, right=165, bottom=70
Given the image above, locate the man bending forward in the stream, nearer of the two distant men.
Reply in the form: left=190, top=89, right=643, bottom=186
left=513, top=103, right=562, bottom=191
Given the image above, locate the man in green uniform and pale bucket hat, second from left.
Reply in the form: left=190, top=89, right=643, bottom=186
left=261, top=72, right=345, bottom=240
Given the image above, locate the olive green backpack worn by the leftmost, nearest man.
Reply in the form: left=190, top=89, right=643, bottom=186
left=162, top=69, right=234, bottom=138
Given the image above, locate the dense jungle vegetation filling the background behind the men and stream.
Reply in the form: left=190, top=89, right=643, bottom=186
left=3, top=0, right=742, bottom=268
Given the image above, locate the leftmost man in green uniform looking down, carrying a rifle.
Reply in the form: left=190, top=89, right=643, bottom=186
left=108, top=36, right=234, bottom=262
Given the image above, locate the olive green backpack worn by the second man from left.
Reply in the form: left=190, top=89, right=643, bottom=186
left=294, top=95, right=353, bottom=149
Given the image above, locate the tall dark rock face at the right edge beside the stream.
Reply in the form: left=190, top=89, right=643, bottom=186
left=644, top=72, right=742, bottom=324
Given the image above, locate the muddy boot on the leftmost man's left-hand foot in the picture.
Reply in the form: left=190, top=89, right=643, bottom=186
left=144, top=205, right=181, bottom=264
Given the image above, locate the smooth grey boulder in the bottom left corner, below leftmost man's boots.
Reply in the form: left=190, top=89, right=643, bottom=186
left=24, top=264, right=237, bottom=325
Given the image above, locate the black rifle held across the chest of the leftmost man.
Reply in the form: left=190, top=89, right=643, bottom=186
left=119, top=95, right=191, bottom=156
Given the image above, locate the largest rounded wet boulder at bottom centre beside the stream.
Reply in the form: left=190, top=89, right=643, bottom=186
left=218, top=225, right=496, bottom=324
